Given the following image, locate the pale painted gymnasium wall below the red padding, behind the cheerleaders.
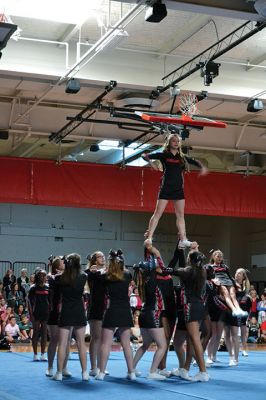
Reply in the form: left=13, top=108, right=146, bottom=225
left=0, top=204, right=266, bottom=281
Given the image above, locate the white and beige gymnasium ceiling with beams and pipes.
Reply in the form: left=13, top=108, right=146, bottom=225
left=0, top=0, right=266, bottom=175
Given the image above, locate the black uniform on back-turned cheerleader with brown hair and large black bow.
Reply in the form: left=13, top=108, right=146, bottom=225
left=103, top=271, right=133, bottom=328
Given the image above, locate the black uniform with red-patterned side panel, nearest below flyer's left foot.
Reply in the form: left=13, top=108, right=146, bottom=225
left=139, top=269, right=165, bottom=329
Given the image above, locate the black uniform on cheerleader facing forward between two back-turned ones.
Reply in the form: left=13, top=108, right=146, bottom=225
left=85, top=269, right=105, bottom=321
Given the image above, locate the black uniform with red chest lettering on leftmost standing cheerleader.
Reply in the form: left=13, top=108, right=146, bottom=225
left=28, top=284, right=50, bottom=321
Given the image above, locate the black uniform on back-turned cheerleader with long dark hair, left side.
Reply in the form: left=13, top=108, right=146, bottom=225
left=55, top=272, right=87, bottom=327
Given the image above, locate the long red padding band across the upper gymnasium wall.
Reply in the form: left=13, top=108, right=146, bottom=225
left=0, top=157, right=266, bottom=218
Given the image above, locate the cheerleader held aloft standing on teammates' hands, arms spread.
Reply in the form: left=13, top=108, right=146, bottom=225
left=143, top=134, right=208, bottom=248
